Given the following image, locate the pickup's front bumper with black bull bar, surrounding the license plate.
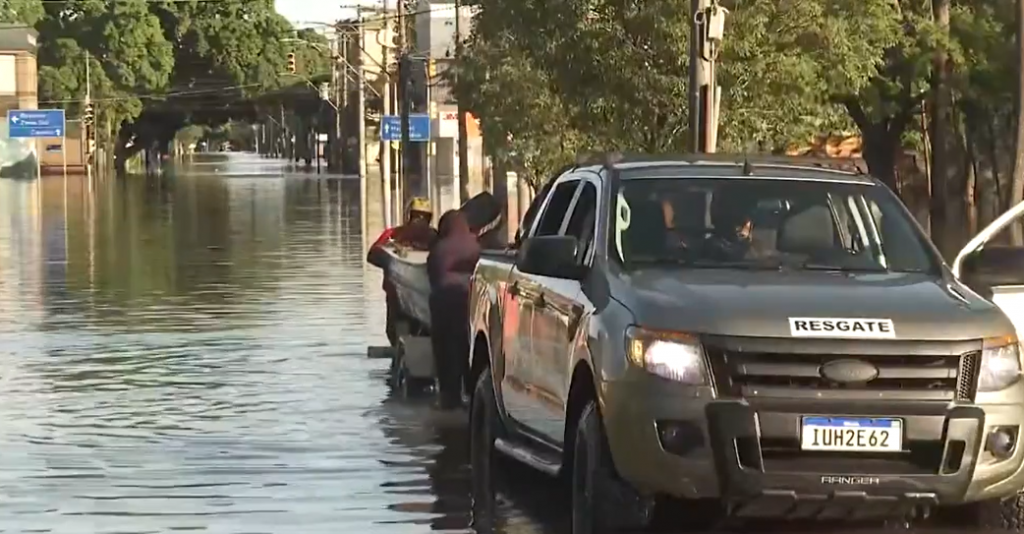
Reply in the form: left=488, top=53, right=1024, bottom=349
left=603, top=380, right=1024, bottom=519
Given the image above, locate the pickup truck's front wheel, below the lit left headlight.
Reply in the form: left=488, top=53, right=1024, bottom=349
left=570, top=401, right=653, bottom=534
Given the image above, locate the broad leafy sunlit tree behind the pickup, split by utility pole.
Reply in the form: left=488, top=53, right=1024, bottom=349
left=453, top=0, right=902, bottom=185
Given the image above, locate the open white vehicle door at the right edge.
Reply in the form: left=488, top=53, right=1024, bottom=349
left=952, top=202, right=1024, bottom=338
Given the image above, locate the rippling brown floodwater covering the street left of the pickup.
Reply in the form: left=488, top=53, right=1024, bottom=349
left=0, top=155, right=564, bottom=534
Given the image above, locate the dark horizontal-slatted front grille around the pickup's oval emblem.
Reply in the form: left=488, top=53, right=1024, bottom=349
left=708, top=346, right=981, bottom=401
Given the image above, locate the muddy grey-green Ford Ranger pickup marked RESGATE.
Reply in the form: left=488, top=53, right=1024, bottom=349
left=466, top=155, right=1024, bottom=534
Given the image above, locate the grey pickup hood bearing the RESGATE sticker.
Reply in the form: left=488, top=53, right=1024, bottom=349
left=612, top=269, right=1014, bottom=340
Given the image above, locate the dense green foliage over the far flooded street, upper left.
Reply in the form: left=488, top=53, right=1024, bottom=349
left=27, top=0, right=329, bottom=169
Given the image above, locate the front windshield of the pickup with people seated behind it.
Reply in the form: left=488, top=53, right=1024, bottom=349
left=610, top=177, right=939, bottom=274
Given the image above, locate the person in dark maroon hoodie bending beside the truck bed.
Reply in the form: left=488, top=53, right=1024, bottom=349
left=427, top=210, right=480, bottom=410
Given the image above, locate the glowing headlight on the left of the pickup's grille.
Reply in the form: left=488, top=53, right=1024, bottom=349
left=626, top=327, right=708, bottom=385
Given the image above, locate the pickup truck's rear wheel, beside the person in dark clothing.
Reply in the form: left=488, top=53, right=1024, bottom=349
left=469, top=369, right=502, bottom=528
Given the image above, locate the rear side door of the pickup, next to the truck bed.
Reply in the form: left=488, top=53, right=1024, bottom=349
left=501, top=175, right=580, bottom=433
